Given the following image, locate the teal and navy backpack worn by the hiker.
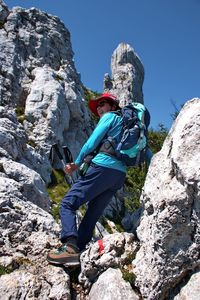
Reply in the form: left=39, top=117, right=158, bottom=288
left=100, top=102, right=150, bottom=167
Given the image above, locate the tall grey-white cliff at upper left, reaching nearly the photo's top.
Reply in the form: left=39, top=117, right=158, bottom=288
left=0, top=4, right=92, bottom=182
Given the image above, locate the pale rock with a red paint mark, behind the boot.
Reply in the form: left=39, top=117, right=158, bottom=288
left=79, top=232, right=138, bottom=289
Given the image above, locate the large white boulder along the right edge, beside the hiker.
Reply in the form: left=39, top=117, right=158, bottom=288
left=134, top=99, right=200, bottom=300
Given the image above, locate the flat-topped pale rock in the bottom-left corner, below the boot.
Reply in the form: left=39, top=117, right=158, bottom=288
left=0, top=266, right=71, bottom=300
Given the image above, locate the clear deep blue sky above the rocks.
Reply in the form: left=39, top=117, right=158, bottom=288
left=4, top=0, right=200, bottom=129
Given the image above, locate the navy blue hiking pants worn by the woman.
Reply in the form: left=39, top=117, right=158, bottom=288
left=60, top=164, right=126, bottom=250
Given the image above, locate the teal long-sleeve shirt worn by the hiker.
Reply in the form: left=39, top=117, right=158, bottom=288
left=75, top=112, right=126, bottom=172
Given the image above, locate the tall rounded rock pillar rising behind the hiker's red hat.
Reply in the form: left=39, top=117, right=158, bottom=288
left=104, top=43, right=144, bottom=107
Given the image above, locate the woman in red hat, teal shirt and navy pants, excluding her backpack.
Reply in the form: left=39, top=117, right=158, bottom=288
left=47, top=94, right=126, bottom=266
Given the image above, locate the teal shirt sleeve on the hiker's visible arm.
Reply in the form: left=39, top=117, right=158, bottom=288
left=75, top=112, right=115, bottom=165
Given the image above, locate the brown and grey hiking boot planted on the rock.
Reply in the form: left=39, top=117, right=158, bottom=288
left=47, top=244, right=80, bottom=266
